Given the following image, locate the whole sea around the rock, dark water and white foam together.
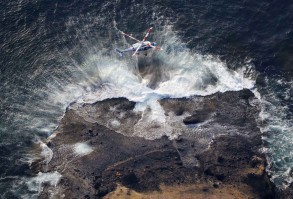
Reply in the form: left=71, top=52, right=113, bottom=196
left=0, top=0, right=293, bottom=198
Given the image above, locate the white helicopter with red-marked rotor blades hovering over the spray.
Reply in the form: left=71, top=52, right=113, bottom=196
left=115, top=27, right=163, bottom=57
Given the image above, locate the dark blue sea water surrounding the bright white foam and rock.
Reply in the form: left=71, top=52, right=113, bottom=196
left=0, top=0, right=293, bottom=198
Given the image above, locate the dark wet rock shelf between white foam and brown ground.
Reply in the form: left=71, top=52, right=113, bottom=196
left=37, top=90, right=275, bottom=198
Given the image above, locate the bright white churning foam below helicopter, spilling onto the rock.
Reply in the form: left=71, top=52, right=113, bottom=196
left=49, top=27, right=254, bottom=139
